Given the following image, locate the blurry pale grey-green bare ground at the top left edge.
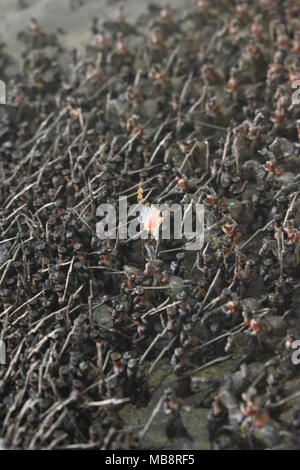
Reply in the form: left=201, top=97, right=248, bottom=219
left=0, top=0, right=193, bottom=58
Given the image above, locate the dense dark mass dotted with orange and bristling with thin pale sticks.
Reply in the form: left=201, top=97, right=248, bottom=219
left=0, top=0, right=300, bottom=450
